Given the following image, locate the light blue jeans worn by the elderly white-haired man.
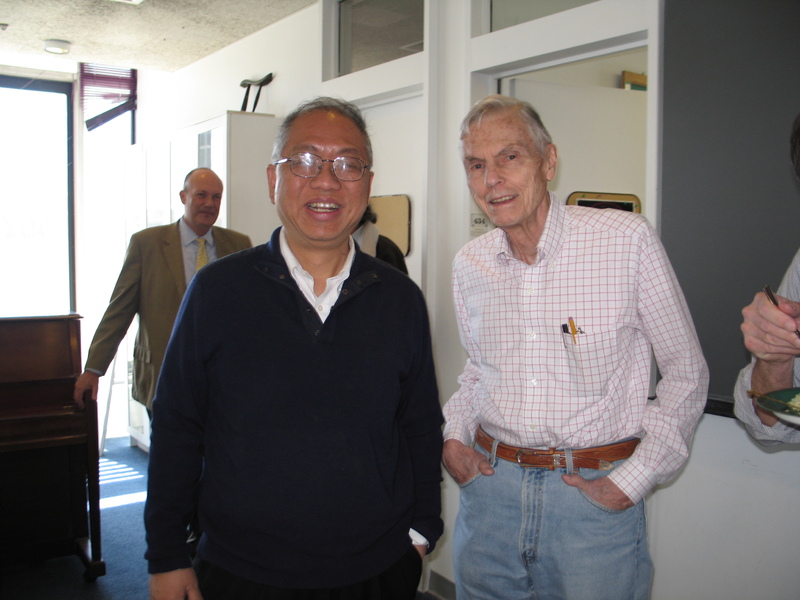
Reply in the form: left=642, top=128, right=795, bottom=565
left=453, top=447, right=653, bottom=600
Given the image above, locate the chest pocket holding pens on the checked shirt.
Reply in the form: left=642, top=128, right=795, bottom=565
left=562, top=330, right=618, bottom=397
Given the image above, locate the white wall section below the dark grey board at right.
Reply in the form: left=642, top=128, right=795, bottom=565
left=648, top=415, right=800, bottom=600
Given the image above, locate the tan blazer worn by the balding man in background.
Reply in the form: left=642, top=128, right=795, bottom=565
left=86, top=223, right=253, bottom=408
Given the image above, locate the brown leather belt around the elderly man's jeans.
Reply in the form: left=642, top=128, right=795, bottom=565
left=475, top=427, right=641, bottom=471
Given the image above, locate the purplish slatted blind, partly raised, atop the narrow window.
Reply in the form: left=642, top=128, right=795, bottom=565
left=80, top=63, right=136, bottom=131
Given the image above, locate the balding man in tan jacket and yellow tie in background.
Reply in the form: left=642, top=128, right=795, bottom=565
left=74, top=168, right=252, bottom=411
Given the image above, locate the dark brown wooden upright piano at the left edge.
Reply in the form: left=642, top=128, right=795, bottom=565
left=0, top=315, right=106, bottom=581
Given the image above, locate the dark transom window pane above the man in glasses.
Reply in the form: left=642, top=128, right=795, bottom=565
left=339, top=0, right=425, bottom=75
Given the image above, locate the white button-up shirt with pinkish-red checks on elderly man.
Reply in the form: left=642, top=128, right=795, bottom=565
left=444, top=194, right=708, bottom=502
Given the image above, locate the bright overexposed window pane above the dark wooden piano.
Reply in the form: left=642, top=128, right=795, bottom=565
left=0, top=87, right=71, bottom=317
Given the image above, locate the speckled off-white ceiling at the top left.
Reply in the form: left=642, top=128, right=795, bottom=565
left=0, top=0, right=317, bottom=71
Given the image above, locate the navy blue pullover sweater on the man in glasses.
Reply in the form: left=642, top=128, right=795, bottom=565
left=145, top=230, right=442, bottom=588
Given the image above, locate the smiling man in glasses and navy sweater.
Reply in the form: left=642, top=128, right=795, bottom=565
left=145, top=98, right=442, bottom=600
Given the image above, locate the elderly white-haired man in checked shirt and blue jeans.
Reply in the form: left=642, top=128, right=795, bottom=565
left=443, top=96, right=708, bottom=600
